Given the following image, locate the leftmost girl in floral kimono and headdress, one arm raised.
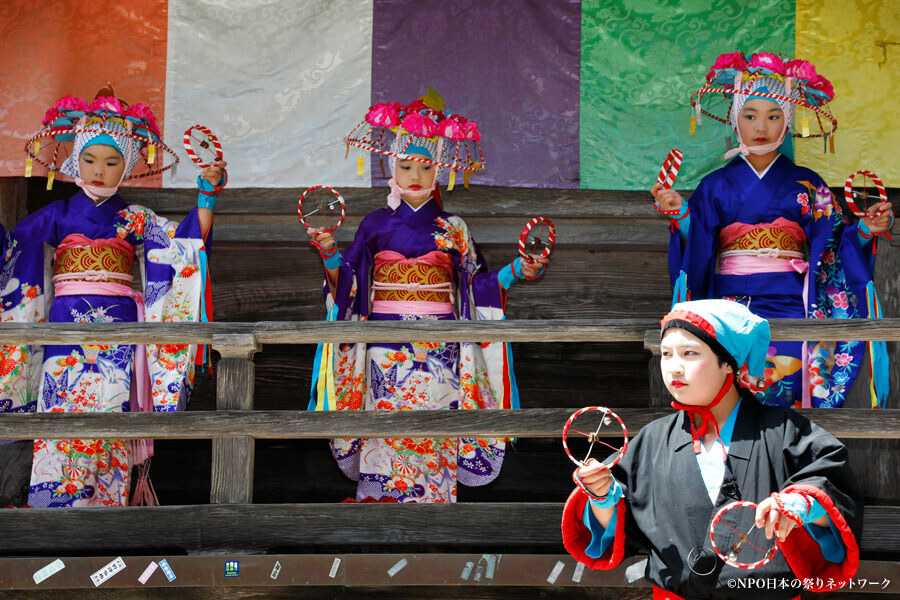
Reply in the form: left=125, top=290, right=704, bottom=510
left=0, top=96, right=225, bottom=507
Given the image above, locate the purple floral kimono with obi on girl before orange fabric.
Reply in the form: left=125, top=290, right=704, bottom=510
left=0, top=192, right=208, bottom=507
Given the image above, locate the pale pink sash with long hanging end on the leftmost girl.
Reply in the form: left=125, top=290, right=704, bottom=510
left=54, top=280, right=153, bottom=464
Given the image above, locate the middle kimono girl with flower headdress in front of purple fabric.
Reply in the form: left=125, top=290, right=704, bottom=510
left=308, top=98, right=547, bottom=502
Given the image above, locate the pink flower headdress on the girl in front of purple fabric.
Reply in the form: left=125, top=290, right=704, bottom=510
left=344, top=88, right=484, bottom=190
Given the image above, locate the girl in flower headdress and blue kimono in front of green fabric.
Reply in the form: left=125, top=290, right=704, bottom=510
left=651, top=52, right=893, bottom=407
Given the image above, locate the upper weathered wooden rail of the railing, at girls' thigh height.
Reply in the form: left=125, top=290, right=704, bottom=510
left=0, top=318, right=900, bottom=344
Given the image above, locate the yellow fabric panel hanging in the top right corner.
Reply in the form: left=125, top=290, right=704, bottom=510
left=795, top=0, right=900, bottom=187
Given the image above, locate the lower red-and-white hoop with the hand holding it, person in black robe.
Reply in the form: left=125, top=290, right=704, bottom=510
left=709, top=493, right=803, bottom=570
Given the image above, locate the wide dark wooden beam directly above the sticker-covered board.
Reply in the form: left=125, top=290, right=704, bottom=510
left=0, top=502, right=900, bottom=556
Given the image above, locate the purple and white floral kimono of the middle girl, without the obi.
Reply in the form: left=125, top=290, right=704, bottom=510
left=310, top=199, right=518, bottom=502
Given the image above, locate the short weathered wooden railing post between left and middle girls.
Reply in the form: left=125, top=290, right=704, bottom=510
left=209, top=334, right=259, bottom=504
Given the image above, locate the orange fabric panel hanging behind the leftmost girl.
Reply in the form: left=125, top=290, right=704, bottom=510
left=0, top=0, right=168, bottom=187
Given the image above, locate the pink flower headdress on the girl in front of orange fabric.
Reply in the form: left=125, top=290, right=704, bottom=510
left=25, top=88, right=178, bottom=190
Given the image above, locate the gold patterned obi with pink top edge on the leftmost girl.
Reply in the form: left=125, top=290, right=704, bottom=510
left=53, top=235, right=134, bottom=285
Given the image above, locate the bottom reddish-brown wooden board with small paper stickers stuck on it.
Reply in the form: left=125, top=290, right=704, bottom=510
left=0, top=553, right=900, bottom=597
